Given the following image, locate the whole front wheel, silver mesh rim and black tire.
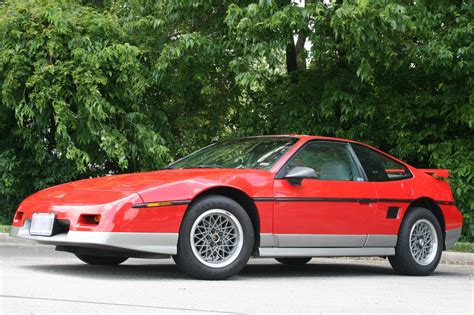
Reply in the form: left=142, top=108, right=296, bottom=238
left=173, top=196, right=254, bottom=280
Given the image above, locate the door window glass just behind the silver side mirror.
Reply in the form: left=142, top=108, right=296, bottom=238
left=286, top=141, right=363, bottom=181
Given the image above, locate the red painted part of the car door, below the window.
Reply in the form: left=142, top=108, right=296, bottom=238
left=274, top=179, right=375, bottom=234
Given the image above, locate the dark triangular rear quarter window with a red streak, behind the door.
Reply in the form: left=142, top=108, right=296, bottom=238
left=351, top=143, right=412, bottom=182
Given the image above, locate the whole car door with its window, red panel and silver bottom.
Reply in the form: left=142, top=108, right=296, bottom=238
left=274, top=140, right=376, bottom=247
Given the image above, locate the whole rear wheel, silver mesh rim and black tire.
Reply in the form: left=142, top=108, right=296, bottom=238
left=389, top=208, right=443, bottom=276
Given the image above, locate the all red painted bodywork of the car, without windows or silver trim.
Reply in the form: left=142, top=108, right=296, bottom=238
left=13, top=136, right=462, bottom=239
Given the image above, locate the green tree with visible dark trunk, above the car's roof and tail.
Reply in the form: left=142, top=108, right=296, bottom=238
left=226, top=0, right=474, bottom=239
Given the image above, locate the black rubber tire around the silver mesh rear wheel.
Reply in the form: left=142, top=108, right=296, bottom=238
left=388, top=207, right=444, bottom=276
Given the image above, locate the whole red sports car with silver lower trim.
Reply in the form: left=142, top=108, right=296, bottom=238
left=11, top=135, right=462, bottom=279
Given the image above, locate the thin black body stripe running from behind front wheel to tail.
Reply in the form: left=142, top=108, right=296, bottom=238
left=253, top=197, right=454, bottom=205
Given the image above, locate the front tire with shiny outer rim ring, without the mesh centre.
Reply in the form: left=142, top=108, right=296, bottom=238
left=173, top=195, right=254, bottom=280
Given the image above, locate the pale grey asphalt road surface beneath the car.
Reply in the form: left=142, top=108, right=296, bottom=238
left=0, top=244, right=474, bottom=314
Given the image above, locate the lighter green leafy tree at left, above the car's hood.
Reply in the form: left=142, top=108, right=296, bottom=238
left=0, top=1, right=169, bottom=222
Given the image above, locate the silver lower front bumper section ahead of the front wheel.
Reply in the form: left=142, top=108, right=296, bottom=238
left=10, top=221, right=178, bottom=255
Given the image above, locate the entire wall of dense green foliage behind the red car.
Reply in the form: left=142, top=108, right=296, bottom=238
left=0, top=0, right=474, bottom=240
